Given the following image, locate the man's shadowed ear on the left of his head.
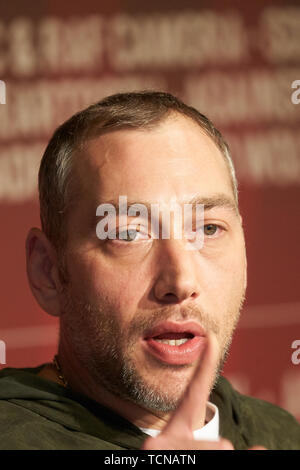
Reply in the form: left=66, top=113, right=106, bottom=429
left=26, top=228, right=62, bottom=316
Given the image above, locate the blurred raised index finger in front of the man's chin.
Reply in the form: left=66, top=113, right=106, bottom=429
left=162, top=333, right=219, bottom=435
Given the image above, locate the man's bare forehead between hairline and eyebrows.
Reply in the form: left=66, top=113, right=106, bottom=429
left=74, top=116, right=233, bottom=204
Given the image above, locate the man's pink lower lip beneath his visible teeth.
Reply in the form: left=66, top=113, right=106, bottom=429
left=144, top=336, right=205, bottom=365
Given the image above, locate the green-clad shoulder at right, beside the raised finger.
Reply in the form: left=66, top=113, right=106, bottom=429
left=221, top=377, right=300, bottom=450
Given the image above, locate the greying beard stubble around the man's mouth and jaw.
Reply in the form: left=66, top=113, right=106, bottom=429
left=60, top=284, right=245, bottom=412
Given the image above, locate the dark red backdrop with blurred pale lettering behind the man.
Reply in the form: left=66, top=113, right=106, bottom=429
left=0, top=0, right=300, bottom=419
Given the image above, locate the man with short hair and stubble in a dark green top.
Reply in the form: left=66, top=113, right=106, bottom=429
left=0, top=92, right=300, bottom=449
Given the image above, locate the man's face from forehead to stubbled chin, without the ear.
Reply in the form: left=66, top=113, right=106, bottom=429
left=61, top=116, right=246, bottom=411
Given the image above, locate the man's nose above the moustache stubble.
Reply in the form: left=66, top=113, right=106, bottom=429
left=153, top=240, right=200, bottom=303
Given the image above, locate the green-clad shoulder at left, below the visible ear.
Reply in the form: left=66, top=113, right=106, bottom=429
left=0, top=367, right=125, bottom=450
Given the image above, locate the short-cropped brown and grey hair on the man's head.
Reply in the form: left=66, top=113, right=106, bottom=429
left=39, top=91, right=238, bottom=253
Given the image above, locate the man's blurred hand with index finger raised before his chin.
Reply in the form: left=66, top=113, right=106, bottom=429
left=142, top=333, right=265, bottom=450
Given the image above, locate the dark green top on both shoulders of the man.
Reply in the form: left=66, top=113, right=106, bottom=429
left=0, top=364, right=300, bottom=450
